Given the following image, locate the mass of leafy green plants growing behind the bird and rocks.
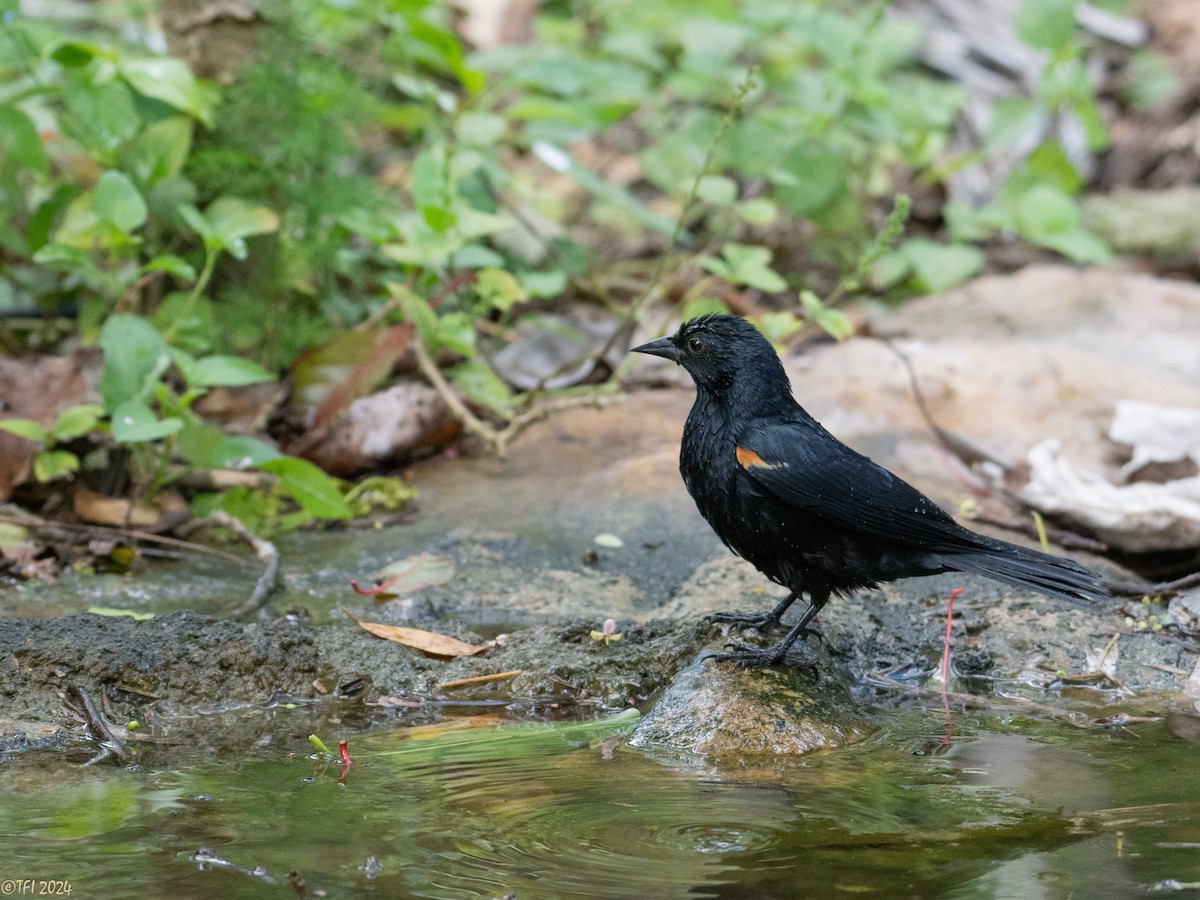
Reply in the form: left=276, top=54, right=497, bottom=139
left=0, top=0, right=1142, bottom=514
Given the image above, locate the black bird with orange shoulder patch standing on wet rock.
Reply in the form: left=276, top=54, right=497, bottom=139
left=634, top=316, right=1108, bottom=666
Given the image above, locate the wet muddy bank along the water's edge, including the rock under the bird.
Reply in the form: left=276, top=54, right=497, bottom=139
left=0, top=566, right=1196, bottom=766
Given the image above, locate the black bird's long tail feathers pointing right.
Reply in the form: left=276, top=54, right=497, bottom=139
left=943, top=541, right=1110, bottom=606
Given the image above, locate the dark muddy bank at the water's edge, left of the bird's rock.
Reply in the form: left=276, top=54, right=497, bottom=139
left=0, top=612, right=704, bottom=761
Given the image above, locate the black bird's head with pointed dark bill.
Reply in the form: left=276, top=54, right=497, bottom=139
left=632, top=316, right=791, bottom=396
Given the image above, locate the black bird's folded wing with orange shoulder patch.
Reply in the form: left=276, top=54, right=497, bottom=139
left=737, top=419, right=978, bottom=551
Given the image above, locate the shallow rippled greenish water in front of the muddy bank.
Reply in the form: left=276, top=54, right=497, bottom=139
left=0, top=708, right=1200, bottom=900
